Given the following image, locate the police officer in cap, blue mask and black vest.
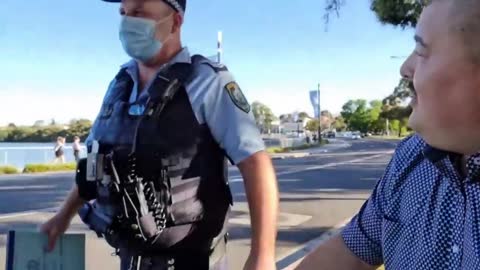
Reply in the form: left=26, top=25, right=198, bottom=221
left=41, top=0, right=278, bottom=270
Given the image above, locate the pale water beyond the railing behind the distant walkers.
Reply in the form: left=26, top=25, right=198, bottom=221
left=0, top=142, right=86, bottom=170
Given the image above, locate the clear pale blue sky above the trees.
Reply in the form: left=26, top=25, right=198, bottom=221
left=0, top=0, right=414, bottom=125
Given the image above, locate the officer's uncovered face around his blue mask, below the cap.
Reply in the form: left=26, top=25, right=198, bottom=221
left=120, top=0, right=178, bottom=41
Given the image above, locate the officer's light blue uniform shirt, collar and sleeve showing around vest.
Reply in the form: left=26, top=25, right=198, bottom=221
left=104, top=48, right=265, bottom=164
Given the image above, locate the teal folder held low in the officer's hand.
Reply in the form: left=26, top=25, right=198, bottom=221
left=5, top=231, right=85, bottom=270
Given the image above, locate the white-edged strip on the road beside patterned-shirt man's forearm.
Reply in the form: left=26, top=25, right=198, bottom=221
left=277, top=218, right=351, bottom=270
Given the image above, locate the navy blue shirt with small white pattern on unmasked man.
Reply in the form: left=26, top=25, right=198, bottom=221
left=342, top=135, right=480, bottom=270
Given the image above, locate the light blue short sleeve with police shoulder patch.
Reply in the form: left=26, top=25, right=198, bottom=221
left=197, top=67, right=265, bottom=164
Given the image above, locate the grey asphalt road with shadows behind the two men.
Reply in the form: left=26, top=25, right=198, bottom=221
left=0, top=140, right=396, bottom=270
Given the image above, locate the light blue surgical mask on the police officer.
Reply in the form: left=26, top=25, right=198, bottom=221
left=119, top=16, right=170, bottom=62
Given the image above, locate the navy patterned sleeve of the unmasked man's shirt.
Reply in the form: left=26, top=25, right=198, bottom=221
left=342, top=158, right=394, bottom=265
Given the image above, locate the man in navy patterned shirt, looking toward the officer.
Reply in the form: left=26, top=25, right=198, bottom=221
left=297, top=0, right=480, bottom=270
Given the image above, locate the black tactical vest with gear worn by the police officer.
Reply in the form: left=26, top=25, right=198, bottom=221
left=80, top=56, right=232, bottom=252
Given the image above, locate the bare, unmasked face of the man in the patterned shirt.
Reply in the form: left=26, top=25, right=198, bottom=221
left=401, top=1, right=480, bottom=154
